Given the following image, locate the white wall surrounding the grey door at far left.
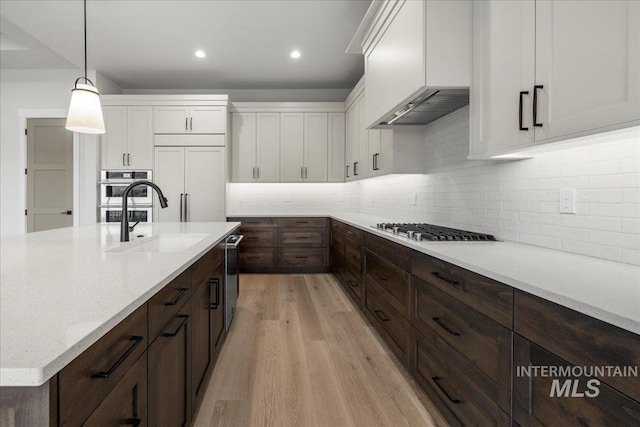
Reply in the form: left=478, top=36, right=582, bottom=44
left=0, top=70, right=98, bottom=236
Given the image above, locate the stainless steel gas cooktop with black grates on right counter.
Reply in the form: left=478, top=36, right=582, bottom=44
left=371, top=223, right=496, bottom=242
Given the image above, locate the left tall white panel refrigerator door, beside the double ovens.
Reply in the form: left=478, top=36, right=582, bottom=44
left=152, top=147, right=185, bottom=222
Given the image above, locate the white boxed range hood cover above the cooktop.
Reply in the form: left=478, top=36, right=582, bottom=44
left=362, top=0, right=471, bottom=127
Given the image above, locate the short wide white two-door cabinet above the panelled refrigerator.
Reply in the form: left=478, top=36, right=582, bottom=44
left=154, top=106, right=227, bottom=134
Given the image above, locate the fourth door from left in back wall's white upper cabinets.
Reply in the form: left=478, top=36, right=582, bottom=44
left=304, top=113, right=329, bottom=182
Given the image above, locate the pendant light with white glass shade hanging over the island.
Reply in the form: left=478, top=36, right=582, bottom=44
left=65, top=0, right=104, bottom=134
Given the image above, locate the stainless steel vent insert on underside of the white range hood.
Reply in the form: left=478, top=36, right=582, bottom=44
left=375, top=88, right=469, bottom=128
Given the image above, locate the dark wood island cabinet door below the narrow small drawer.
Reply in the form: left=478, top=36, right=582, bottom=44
left=147, top=303, right=193, bottom=427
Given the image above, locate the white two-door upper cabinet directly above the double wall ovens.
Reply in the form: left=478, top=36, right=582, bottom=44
left=100, top=105, right=153, bottom=169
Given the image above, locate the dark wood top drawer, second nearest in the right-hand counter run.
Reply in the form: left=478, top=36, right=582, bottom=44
left=411, top=251, right=513, bottom=329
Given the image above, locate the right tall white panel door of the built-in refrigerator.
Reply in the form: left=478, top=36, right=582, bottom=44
left=184, top=147, right=226, bottom=222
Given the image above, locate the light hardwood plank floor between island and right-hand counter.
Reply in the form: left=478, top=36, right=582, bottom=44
left=194, top=274, right=446, bottom=427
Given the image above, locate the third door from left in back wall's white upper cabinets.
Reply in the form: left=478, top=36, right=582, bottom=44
left=280, top=113, right=304, bottom=182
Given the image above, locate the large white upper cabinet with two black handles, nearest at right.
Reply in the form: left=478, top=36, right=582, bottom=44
left=470, top=0, right=640, bottom=158
